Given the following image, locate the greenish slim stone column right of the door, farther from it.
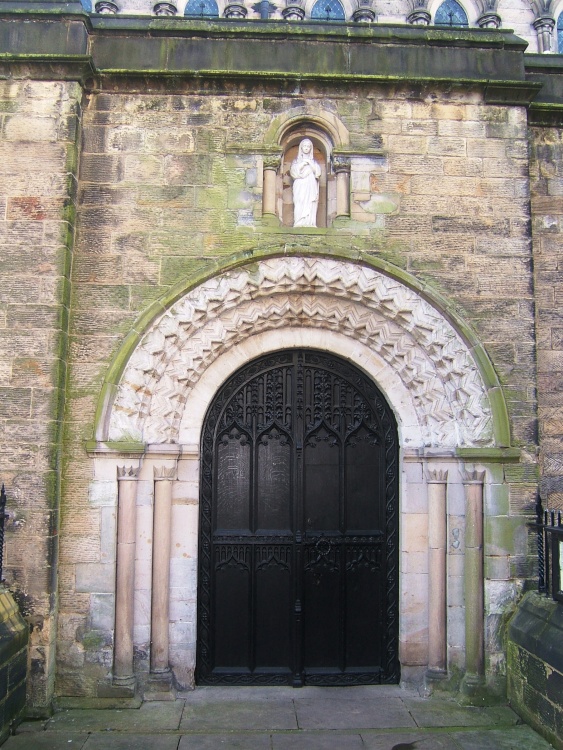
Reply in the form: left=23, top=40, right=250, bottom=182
left=461, top=471, right=485, bottom=698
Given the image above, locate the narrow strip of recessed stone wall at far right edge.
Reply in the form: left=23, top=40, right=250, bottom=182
left=530, top=128, right=563, bottom=508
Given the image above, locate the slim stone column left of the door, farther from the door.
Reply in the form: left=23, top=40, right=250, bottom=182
left=113, top=466, right=139, bottom=690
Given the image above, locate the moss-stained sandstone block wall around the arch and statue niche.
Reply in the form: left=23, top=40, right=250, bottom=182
left=57, top=84, right=537, bottom=695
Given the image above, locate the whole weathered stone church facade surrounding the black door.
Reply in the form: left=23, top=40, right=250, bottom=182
left=0, top=0, right=563, bottom=748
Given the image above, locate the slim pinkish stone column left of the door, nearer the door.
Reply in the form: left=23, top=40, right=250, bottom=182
left=144, top=466, right=176, bottom=700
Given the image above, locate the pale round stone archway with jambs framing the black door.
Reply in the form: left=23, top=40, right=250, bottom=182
left=91, top=256, right=508, bottom=696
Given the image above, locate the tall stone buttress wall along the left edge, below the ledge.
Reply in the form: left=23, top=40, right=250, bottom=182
left=0, top=80, right=81, bottom=711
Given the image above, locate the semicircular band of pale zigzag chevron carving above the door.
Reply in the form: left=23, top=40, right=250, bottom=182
left=108, top=258, right=493, bottom=448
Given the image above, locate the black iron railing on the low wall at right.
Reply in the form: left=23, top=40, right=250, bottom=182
left=534, top=497, right=563, bottom=602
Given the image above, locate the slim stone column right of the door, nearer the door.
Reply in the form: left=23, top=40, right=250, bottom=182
left=426, top=470, right=448, bottom=682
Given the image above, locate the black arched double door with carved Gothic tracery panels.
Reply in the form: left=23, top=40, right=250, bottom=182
left=196, top=350, right=399, bottom=686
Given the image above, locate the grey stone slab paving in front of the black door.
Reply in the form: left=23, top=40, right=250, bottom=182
left=3, top=686, right=551, bottom=750
